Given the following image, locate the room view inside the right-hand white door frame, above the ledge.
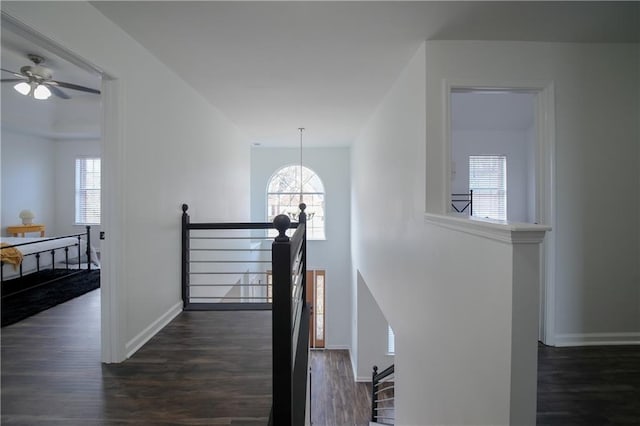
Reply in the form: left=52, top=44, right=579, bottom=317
left=451, top=90, right=536, bottom=223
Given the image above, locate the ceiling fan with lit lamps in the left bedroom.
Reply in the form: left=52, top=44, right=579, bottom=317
left=0, top=53, right=100, bottom=100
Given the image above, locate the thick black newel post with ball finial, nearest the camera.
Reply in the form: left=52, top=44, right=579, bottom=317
left=271, top=214, right=293, bottom=426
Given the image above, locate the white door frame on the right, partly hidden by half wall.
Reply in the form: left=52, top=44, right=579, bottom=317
left=442, top=79, right=556, bottom=346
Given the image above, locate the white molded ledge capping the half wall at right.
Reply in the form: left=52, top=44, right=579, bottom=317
left=424, top=213, right=551, bottom=244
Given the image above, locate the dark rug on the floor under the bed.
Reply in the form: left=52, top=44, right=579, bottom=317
left=1, top=269, right=100, bottom=327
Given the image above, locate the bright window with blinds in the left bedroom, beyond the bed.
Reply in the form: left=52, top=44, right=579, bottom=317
left=76, top=158, right=100, bottom=225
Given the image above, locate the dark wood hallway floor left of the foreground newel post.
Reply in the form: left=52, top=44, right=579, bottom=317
left=2, top=291, right=271, bottom=426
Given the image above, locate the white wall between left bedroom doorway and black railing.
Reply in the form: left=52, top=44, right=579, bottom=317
left=2, top=2, right=249, bottom=360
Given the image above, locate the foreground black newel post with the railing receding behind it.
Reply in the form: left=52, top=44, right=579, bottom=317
left=269, top=203, right=310, bottom=426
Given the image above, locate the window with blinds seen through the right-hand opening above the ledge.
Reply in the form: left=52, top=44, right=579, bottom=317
left=469, top=155, right=507, bottom=220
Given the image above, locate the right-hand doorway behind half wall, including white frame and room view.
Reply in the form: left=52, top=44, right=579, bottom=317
left=446, top=83, right=555, bottom=345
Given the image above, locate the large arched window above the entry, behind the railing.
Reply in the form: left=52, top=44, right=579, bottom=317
left=267, top=166, right=325, bottom=240
